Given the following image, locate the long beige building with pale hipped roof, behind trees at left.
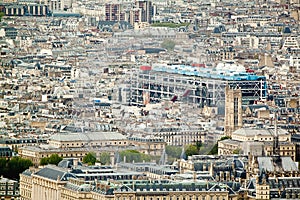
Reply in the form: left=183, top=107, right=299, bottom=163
left=18, top=132, right=166, bottom=166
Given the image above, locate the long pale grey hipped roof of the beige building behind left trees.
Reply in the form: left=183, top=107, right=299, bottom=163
left=49, top=132, right=126, bottom=142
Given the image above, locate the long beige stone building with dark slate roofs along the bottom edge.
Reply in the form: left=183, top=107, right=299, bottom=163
left=20, top=166, right=238, bottom=200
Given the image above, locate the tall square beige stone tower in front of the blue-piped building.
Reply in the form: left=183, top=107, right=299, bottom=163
left=225, top=86, right=243, bottom=136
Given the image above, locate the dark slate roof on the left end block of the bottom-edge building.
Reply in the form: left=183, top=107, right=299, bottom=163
left=35, top=165, right=75, bottom=181
